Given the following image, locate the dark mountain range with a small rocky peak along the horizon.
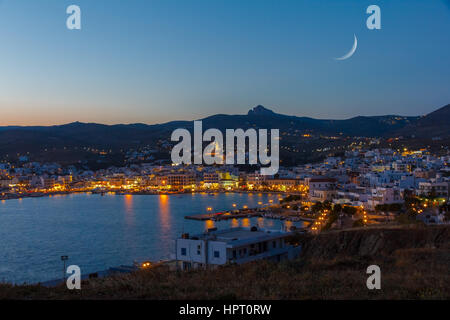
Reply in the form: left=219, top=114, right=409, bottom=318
left=0, top=104, right=450, bottom=165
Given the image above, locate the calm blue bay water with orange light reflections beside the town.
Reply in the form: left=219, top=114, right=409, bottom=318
left=0, top=193, right=300, bottom=283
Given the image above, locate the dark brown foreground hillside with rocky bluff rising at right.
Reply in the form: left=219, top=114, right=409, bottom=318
left=0, top=226, right=450, bottom=300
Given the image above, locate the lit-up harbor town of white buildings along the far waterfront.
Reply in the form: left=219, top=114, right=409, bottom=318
left=0, top=148, right=450, bottom=232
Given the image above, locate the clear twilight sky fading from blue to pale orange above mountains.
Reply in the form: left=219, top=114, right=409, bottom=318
left=0, top=0, right=450, bottom=125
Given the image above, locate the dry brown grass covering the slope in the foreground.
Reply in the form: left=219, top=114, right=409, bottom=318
left=0, top=226, right=450, bottom=300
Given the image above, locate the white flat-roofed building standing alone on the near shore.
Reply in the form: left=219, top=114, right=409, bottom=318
left=175, top=227, right=300, bottom=270
